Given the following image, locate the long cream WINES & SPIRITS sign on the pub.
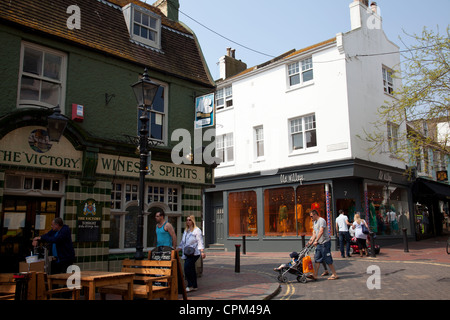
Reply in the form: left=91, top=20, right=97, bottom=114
left=97, top=154, right=205, bottom=183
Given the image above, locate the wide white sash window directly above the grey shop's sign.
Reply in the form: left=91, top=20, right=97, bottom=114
left=288, top=113, right=318, bottom=153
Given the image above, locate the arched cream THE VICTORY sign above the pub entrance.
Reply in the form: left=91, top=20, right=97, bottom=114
left=0, top=127, right=82, bottom=171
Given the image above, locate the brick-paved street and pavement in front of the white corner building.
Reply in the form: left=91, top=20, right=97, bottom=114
left=189, top=237, right=450, bottom=300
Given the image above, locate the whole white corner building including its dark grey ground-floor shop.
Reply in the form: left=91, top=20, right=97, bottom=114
left=205, top=0, right=412, bottom=250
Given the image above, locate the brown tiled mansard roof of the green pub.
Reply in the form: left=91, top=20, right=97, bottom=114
left=0, top=0, right=214, bottom=86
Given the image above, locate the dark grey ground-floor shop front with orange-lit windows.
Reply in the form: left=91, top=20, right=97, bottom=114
left=205, top=160, right=414, bottom=251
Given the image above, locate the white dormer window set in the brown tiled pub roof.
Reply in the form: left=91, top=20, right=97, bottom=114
left=122, top=3, right=161, bottom=49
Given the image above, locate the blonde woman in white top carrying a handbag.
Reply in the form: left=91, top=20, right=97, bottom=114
left=177, top=216, right=206, bottom=292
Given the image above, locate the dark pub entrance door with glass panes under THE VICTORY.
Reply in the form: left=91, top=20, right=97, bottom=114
left=0, top=196, right=61, bottom=272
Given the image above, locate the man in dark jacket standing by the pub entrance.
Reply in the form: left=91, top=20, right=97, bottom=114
left=33, top=218, right=75, bottom=274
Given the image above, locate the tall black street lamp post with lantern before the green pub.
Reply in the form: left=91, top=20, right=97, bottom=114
left=131, top=68, right=160, bottom=260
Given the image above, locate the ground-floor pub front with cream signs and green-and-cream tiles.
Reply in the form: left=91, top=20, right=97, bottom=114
left=0, top=120, right=212, bottom=272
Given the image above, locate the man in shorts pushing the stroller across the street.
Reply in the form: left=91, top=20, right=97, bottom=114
left=308, top=210, right=339, bottom=280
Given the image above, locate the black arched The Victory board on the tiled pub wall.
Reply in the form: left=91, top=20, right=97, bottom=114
left=77, top=199, right=102, bottom=242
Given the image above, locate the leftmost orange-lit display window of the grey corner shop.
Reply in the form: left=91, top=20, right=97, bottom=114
left=228, top=191, right=258, bottom=237
